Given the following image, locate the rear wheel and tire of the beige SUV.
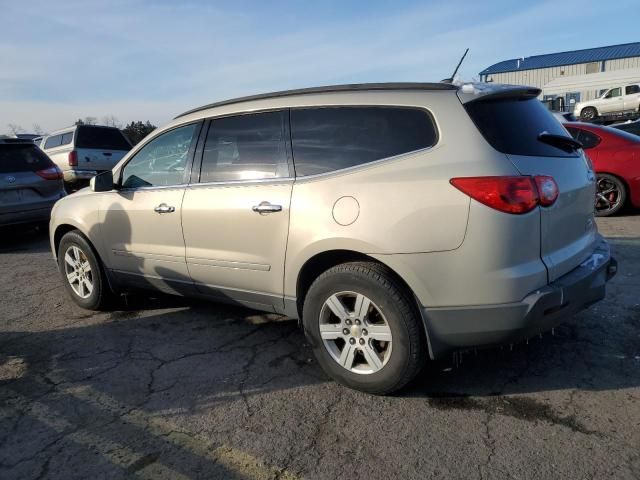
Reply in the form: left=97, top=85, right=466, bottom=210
left=302, top=262, right=428, bottom=395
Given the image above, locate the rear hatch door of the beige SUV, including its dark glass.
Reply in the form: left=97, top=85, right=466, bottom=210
left=465, top=89, right=597, bottom=282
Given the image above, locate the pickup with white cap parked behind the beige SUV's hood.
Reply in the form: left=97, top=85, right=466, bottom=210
left=41, top=125, right=131, bottom=189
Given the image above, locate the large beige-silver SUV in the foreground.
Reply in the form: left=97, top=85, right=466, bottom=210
left=50, top=83, right=616, bottom=393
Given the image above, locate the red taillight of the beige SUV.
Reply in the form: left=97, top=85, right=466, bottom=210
left=450, top=176, right=559, bottom=214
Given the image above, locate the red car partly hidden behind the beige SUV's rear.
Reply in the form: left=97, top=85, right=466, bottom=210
left=563, top=122, right=640, bottom=216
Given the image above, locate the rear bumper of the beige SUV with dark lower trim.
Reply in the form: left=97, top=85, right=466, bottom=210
left=422, top=239, right=617, bottom=358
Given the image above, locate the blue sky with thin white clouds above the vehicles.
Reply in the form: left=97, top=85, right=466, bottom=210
left=0, top=0, right=640, bottom=133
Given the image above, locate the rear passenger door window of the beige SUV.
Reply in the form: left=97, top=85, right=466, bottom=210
left=200, top=112, right=289, bottom=182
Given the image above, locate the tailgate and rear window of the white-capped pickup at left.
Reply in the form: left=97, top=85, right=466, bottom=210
left=75, top=125, right=131, bottom=171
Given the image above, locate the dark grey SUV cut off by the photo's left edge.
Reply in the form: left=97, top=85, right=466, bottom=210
left=0, top=138, right=65, bottom=226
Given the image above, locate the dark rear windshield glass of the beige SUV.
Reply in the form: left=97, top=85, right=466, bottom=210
left=465, top=98, right=577, bottom=157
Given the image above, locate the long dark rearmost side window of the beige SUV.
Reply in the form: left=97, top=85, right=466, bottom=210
left=291, top=107, right=437, bottom=176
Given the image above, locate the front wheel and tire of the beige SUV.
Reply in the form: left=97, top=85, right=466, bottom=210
left=58, top=230, right=113, bottom=310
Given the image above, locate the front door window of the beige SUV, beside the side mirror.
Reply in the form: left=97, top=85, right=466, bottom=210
left=122, top=124, right=197, bottom=188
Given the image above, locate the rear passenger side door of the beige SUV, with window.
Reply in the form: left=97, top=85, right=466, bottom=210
left=182, top=110, right=293, bottom=310
